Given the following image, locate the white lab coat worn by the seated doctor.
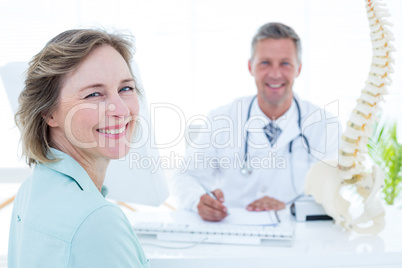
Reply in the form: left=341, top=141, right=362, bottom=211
left=171, top=96, right=341, bottom=211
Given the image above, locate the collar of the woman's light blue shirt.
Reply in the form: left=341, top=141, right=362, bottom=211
left=42, top=148, right=109, bottom=197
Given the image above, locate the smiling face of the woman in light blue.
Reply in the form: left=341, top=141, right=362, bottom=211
left=47, top=45, right=139, bottom=159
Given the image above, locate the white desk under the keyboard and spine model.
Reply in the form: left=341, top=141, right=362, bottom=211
left=0, top=184, right=402, bottom=268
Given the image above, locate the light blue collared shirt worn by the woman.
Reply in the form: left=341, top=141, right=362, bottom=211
left=8, top=149, right=149, bottom=268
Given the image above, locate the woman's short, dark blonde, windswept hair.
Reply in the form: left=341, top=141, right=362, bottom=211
left=14, top=29, right=135, bottom=166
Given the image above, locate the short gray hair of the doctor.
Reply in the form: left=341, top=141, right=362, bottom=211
left=250, top=22, right=301, bottom=63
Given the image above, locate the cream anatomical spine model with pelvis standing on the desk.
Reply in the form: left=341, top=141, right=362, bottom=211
left=306, top=0, right=395, bottom=234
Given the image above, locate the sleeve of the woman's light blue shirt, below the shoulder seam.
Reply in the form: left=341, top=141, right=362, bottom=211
left=70, top=206, right=149, bottom=267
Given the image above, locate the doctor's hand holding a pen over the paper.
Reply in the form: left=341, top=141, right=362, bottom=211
left=197, top=189, right=228, bottom=221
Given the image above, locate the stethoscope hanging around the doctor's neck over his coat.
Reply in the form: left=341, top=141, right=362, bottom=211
left=240, top=96, right=311, bottom=179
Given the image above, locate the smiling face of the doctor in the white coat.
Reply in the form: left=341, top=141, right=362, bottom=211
left=248, top=38, right=301, bottom=107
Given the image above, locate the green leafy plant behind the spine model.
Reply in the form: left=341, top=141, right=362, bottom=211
left=368, top=122, right=402, bottom=205
